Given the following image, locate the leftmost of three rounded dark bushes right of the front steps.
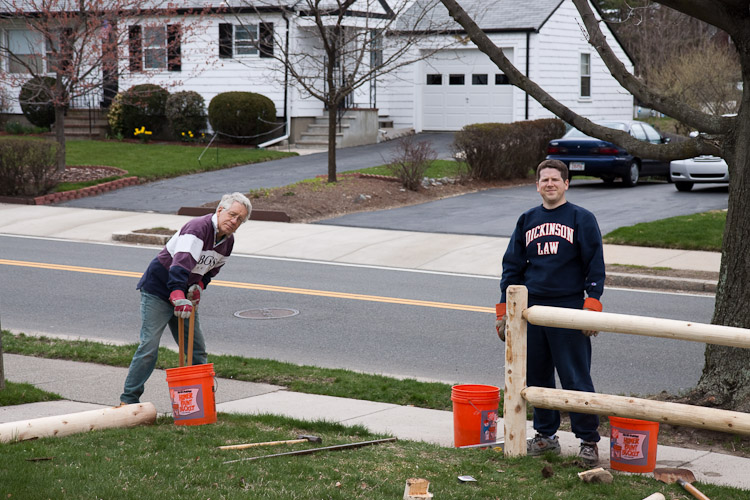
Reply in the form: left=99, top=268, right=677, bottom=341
left=113, top=83, right=169, bottom=137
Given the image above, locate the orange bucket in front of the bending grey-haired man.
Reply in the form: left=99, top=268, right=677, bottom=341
left=167, top=363, right=216, bottom=425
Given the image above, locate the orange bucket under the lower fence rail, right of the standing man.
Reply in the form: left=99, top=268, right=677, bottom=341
left=609, top=417, right=659, bottom=472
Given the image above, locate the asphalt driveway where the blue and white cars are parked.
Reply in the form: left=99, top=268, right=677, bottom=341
left=319, top=179, right=728, bottom=236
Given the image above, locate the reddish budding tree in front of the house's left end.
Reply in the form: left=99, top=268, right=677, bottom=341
left=0, top=0, right=209, bottom=171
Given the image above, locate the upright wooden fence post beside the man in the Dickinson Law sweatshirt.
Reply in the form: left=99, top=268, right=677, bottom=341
left=503, top=285, right=529, bottom=457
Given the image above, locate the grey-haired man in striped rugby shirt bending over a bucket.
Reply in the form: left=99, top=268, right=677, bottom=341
left=120, top=193, right=252, bottom=404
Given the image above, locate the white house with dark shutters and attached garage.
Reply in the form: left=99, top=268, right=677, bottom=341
left=0, top=0, right=633, bottom=145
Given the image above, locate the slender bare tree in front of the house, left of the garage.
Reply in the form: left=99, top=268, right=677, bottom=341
left=229, top=0, right=456, bottom=182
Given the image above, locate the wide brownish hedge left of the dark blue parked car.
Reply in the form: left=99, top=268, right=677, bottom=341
left=453, top=118, right=565, bottom=180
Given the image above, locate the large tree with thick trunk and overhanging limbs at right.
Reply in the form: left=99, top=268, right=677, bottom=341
left=441, top=0, right=750, bottom=411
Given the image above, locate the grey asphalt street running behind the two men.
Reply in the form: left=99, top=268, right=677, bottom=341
left=0, top=236, right=714, bottom=394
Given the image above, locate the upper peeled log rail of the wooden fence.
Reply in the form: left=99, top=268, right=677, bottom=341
left=523, top=306, right=750, bottom=348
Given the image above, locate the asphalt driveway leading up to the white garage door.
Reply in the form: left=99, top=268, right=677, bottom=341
left=61, top=133, right=453, bottom=214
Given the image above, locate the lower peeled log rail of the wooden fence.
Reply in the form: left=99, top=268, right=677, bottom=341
left=521, top=387, right=750, bottom=435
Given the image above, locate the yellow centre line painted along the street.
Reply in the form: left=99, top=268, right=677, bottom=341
left=0, top=259, right=495, bottom=313
